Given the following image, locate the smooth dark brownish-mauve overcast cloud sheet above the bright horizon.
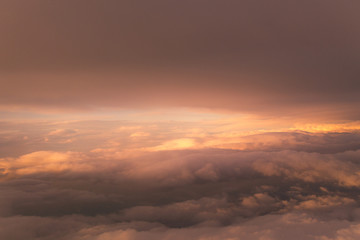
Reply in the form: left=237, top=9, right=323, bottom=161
left=0, top=0, right=360, bottom=116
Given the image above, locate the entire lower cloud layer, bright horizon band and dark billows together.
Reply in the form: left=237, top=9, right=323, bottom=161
left=0, top=121, right=360, bottom=240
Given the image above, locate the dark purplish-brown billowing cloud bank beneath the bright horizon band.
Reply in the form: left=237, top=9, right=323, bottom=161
left=0, top=145, right=360, bottom=239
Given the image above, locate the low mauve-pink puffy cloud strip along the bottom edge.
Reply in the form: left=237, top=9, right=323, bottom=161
left=2, top=213, right=359, bottom=240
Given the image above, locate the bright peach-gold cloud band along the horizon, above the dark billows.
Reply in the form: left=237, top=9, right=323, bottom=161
left=0, top=118, right=360, bottom=158
